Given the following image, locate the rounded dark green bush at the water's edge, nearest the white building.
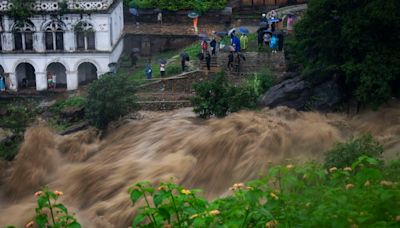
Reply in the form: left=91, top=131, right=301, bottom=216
left=85, top=75, right=136, bottom=129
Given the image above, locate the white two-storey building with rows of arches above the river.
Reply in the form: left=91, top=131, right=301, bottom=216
left=0, top=0, right=124, bottom=91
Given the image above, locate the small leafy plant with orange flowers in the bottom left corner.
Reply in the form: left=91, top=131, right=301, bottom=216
left=32, top=187, right=81, bottom=228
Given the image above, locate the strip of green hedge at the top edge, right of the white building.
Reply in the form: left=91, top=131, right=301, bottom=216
left=126, top=0, right=227, bottom=13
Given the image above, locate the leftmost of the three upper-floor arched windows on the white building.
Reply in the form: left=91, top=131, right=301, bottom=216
left=14, top=21, right=35, bottom=50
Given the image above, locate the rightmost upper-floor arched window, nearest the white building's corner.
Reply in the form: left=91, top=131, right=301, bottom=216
left=75, top=21, right=96, bottom=50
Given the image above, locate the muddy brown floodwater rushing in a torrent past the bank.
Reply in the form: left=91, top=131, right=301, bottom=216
left=0, top=104, right=400, bottom=227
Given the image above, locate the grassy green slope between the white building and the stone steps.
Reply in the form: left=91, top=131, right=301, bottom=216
left=118, top=42, right=200, bottom=85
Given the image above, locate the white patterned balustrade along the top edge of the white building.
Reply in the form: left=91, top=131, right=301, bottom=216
left=0, top=0, right=114, bottom=12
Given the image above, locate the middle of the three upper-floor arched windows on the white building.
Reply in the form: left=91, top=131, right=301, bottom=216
left=45, top=21, right=65, bottom=50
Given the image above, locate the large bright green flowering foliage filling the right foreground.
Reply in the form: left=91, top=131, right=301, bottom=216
left=133, top=156, right=400, bottom=227
